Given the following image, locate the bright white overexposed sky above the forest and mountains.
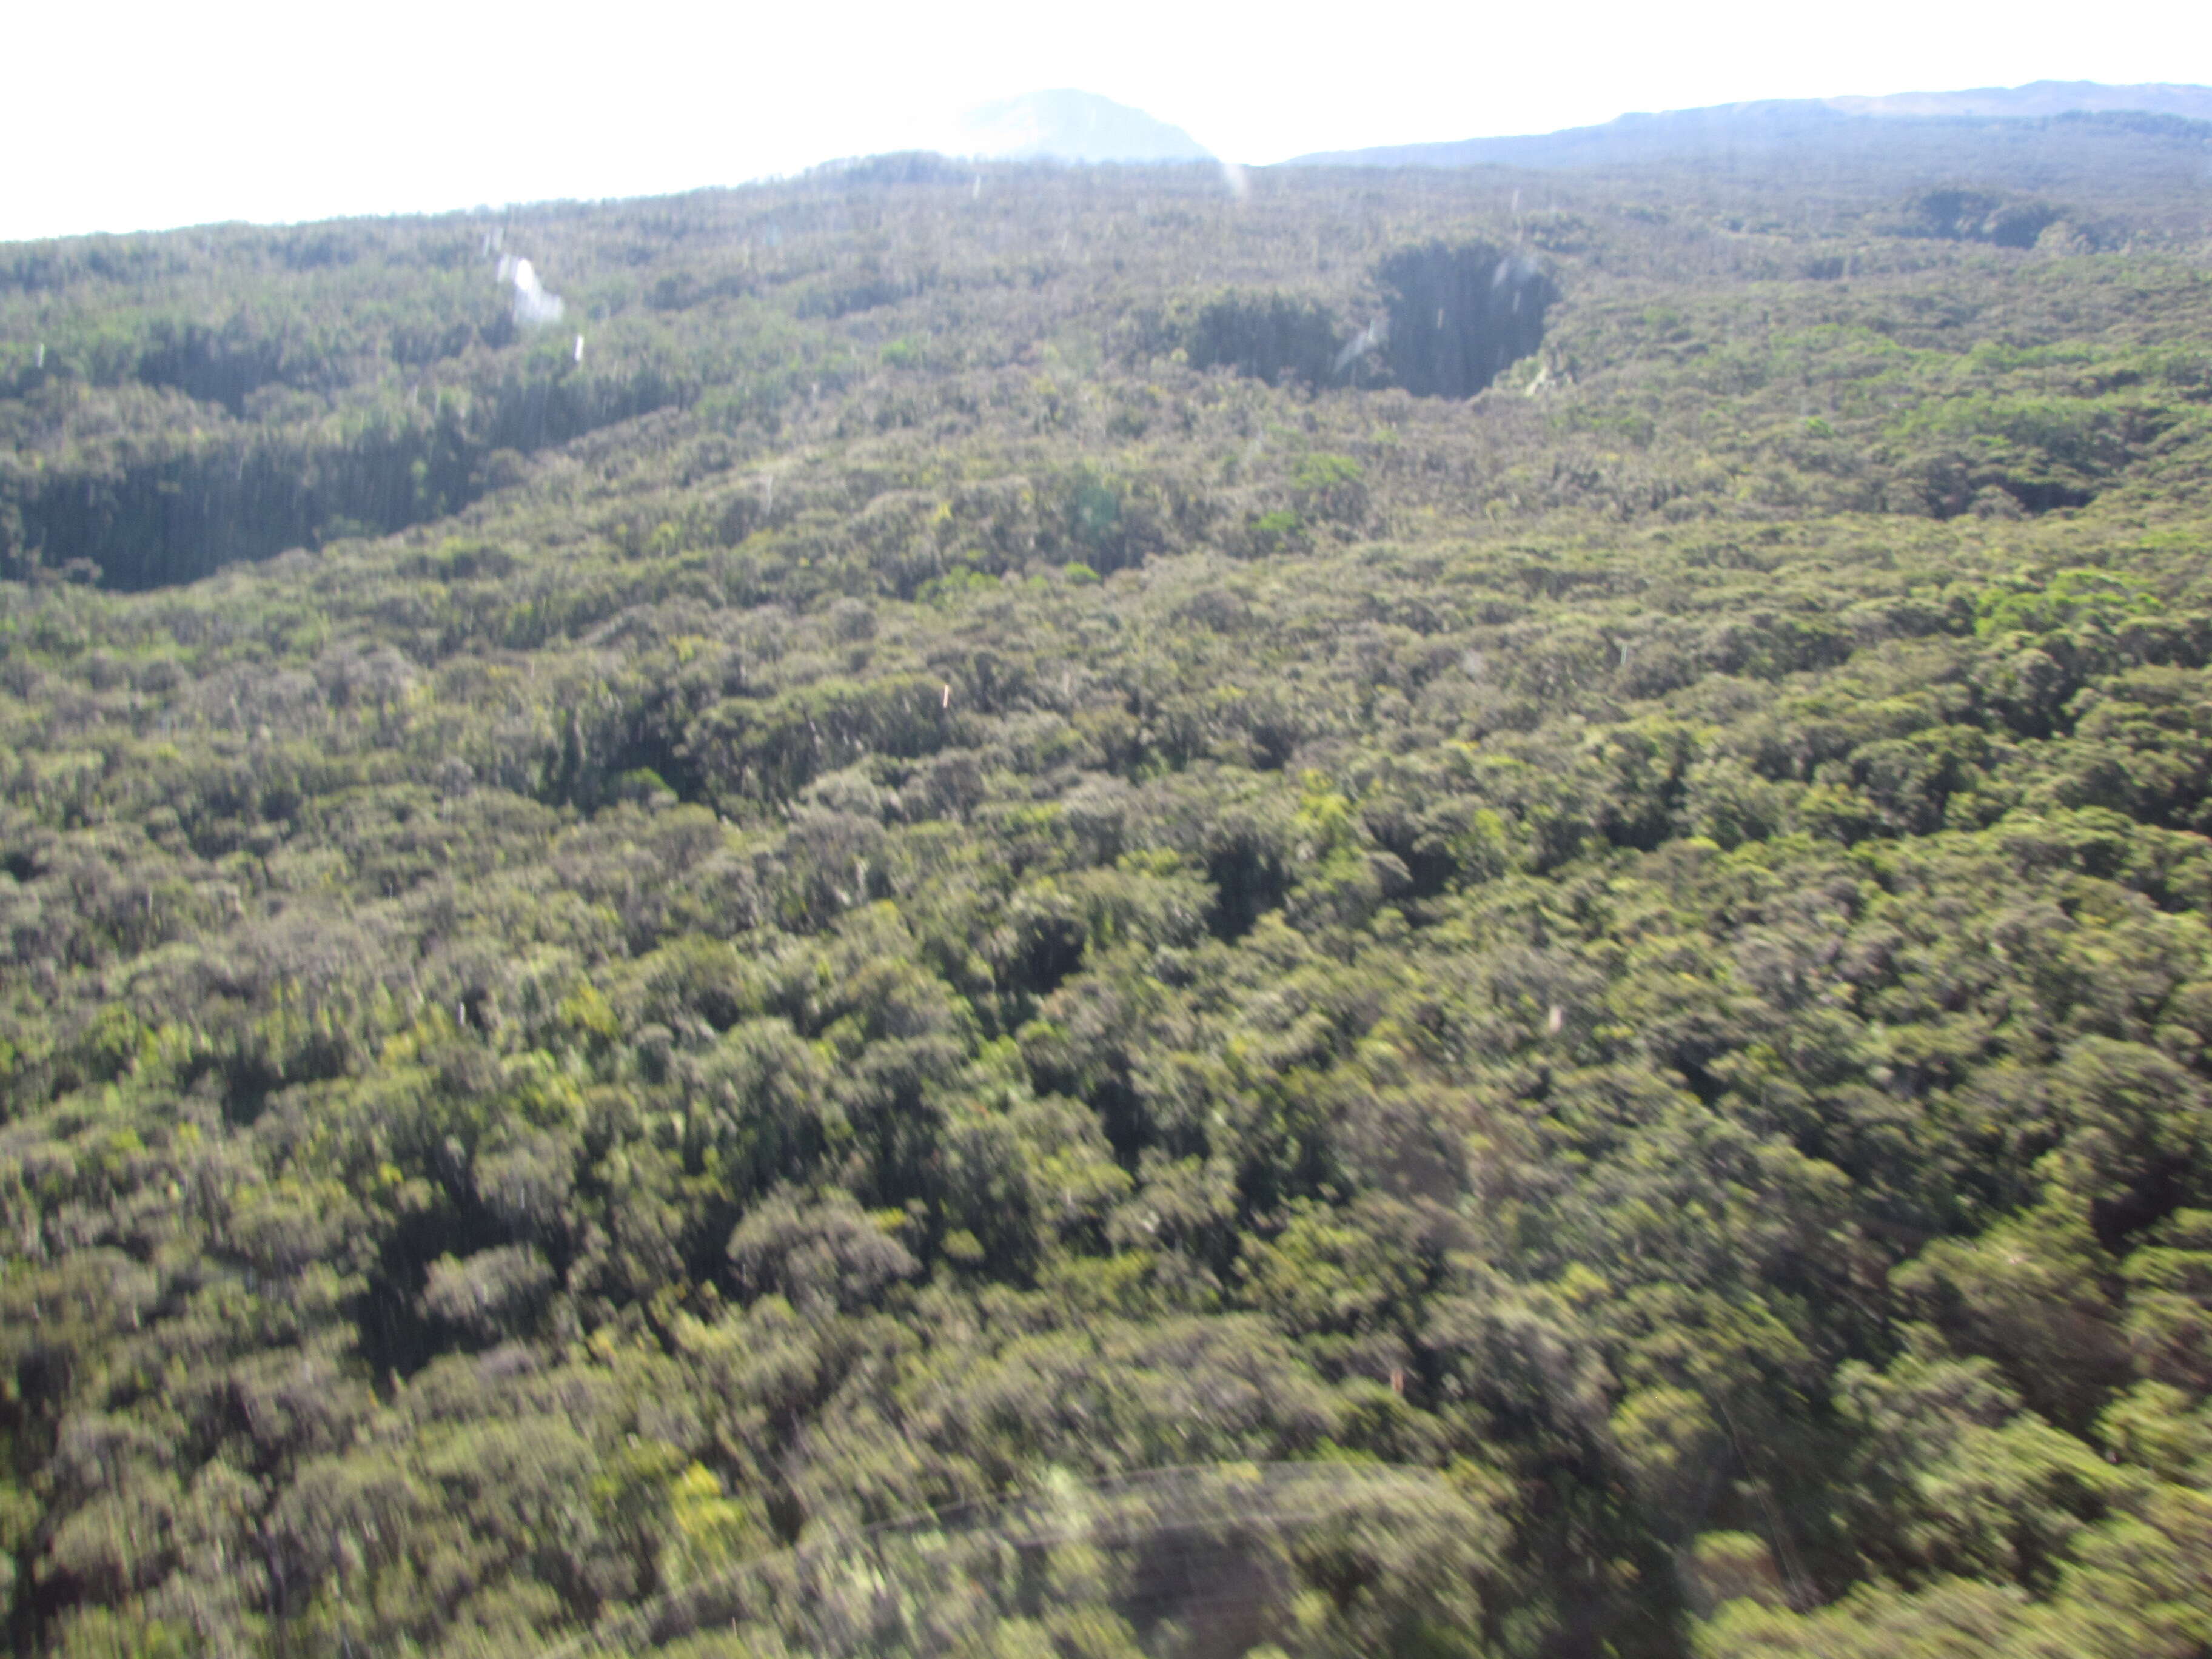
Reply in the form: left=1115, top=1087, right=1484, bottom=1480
left=13, top=0, right=2212, bottom=239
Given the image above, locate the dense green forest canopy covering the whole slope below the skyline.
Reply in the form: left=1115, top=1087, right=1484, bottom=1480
left=0, top=122, right=2212, bottom=1659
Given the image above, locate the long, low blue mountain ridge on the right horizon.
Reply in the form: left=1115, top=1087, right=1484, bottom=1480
left=1285, top=79, right=2212, bottom=168
